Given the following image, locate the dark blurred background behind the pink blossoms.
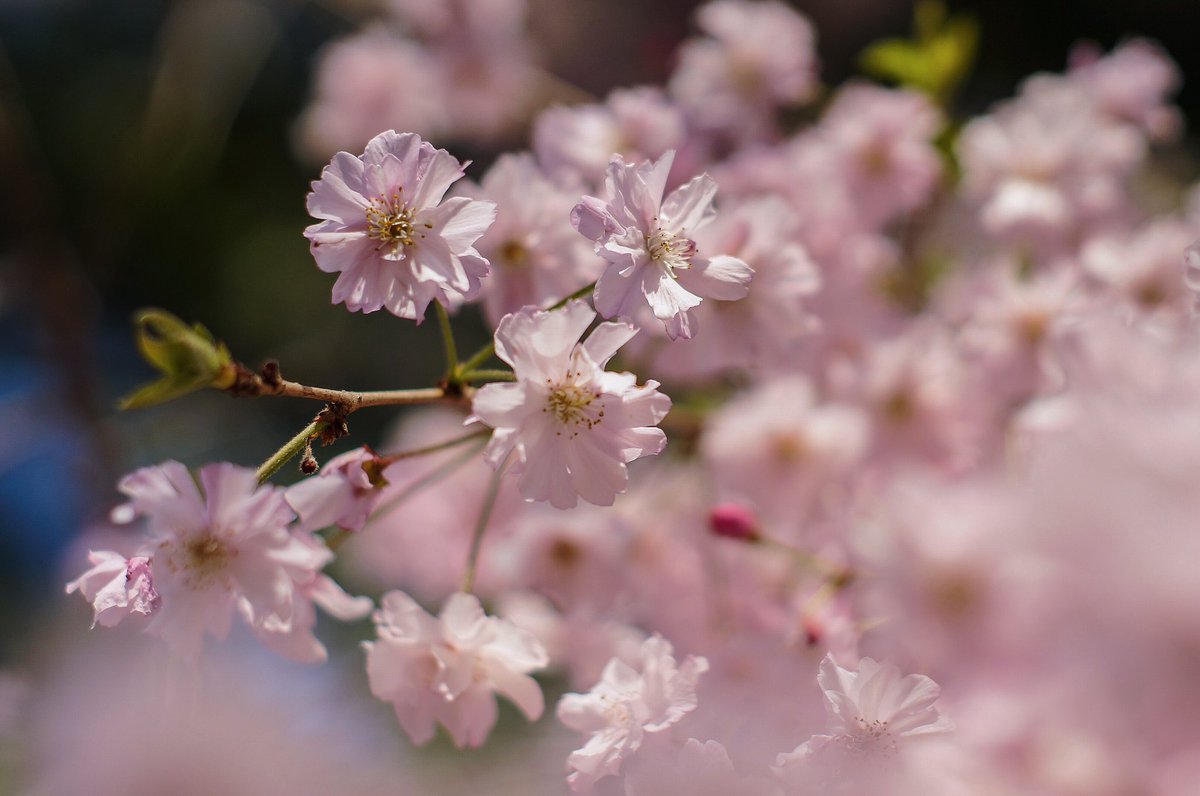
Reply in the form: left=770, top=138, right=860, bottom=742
left=0, top=0, right=1200, bottom=664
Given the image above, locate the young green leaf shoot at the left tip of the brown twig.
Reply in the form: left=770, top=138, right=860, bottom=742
left=120, top=309, right=236, bottom=409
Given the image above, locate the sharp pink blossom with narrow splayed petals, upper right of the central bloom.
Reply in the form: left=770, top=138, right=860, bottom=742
left=571, top=151, right=752, bottom=340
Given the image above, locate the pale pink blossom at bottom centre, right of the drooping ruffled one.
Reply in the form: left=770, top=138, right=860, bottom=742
left=558, top=635, right=708, bottom=791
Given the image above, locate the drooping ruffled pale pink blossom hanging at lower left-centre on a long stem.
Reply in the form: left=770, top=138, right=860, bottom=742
left=362, top=592, right=548, bottom=747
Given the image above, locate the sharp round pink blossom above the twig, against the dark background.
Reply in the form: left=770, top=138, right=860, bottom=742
left=305, top=130, right=496, bottom=322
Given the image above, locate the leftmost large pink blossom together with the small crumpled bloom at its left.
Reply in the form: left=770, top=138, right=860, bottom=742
left=68, top=461, right=371, bottom=663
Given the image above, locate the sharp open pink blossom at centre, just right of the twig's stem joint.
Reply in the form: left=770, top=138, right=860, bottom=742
left=468, top=301, right=671, bottom=509
